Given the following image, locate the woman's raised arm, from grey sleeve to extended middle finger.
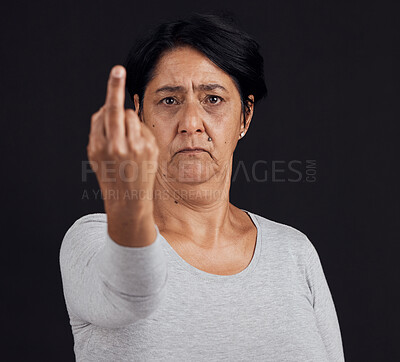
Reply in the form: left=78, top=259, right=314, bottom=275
left=60, top=66, right=167, bottom=328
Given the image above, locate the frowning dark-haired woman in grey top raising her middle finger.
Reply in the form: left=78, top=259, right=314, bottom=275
left=60, top=14, right=344, bottom=362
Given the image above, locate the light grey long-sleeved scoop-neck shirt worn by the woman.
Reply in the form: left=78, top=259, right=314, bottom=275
left=60, top=210, right=344, bottom=362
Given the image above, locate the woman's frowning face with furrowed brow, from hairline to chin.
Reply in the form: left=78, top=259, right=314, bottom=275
left=135, top=47, right=252, bottom=183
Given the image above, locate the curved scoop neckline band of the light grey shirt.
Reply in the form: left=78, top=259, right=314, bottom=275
left=160, top=209, right=262, bottom=282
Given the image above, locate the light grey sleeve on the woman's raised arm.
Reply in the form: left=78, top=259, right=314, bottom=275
left=60, top=214, right=167, bottom=328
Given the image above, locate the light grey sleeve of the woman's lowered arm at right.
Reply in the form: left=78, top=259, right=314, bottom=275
left=306, top=242, right=344, bottom=362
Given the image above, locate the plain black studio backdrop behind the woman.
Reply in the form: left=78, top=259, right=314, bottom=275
left=1, top=0, right=399, bottom=361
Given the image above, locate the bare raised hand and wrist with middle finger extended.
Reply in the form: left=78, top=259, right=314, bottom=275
left=87, top=65, right=159, bottom=246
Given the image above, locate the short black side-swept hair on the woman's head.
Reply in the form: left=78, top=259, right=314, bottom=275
left=124, top=13, right=267, bottom=126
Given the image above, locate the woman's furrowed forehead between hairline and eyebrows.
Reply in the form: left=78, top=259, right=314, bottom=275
left=147, top=46, right=237, bottom=92
